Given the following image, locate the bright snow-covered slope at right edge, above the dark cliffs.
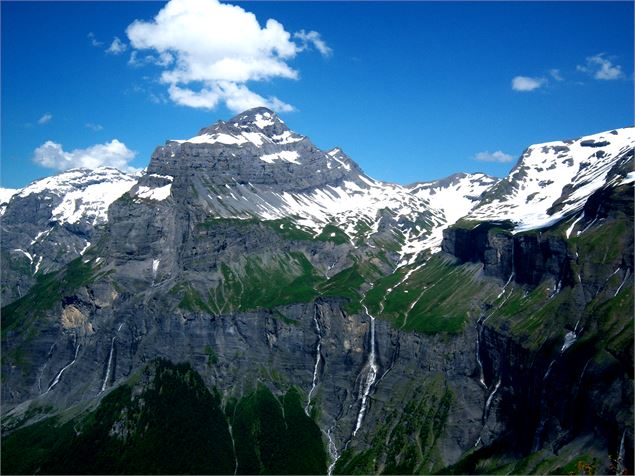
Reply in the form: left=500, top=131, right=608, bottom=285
left=465, top=127, right=635, bottom=232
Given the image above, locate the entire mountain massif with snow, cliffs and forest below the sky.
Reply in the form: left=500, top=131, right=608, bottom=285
left=0, top=108, right=635, bottom=474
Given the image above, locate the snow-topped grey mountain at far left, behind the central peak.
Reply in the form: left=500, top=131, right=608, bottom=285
left=0, top=167, right=137, bottom=305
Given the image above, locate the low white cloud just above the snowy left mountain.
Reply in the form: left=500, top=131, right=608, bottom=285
left=33, top=139, right=136, bottom=171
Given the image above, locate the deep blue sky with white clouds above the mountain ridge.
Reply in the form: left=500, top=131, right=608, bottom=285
left=1, top=0, right=634, bottom=187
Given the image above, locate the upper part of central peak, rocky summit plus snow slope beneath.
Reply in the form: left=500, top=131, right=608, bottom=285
left=143, top=108, right=445, bottom=268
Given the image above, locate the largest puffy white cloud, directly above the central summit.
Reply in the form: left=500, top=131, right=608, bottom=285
left=126, top=0, right=331, bottom=111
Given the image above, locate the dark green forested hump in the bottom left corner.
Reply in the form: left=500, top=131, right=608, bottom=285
left=2, top=360, right=235, bottom=474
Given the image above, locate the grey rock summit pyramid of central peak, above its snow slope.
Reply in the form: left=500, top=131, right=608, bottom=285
left=153, top=108, right=362, bottom=193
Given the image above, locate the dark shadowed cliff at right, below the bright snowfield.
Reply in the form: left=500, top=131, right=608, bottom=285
left=443, top=181, right=633, bottom=470
